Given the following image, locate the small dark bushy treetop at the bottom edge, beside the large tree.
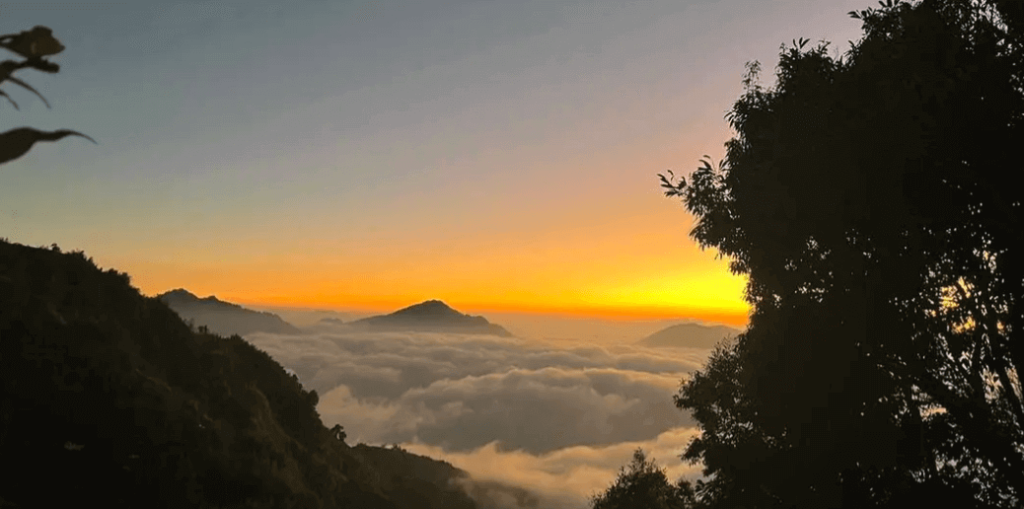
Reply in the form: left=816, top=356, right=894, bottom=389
left=591, top=449, right=695, bottom=509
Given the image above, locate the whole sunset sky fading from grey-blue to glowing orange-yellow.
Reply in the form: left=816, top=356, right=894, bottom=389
left=0, top=0, right=873, bottom=326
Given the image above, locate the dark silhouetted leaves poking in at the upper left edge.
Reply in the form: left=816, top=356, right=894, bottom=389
left=0, top=27, right=96, bottom=164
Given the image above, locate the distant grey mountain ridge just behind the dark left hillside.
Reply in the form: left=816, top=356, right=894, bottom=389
left=157, top=289, right=300, bottom=336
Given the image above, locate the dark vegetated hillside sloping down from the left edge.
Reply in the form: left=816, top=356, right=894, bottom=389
left=0, top=240, right=474, bottom=509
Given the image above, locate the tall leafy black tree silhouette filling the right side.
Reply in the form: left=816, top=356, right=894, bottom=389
left=660, top=0, right=1024, bottom=507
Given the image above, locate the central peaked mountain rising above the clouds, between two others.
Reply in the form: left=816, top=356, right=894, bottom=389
left=351, top=300, right=512, bottom=337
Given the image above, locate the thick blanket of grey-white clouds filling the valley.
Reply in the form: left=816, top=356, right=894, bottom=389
left=246, top=325, right=710, bottom=509
